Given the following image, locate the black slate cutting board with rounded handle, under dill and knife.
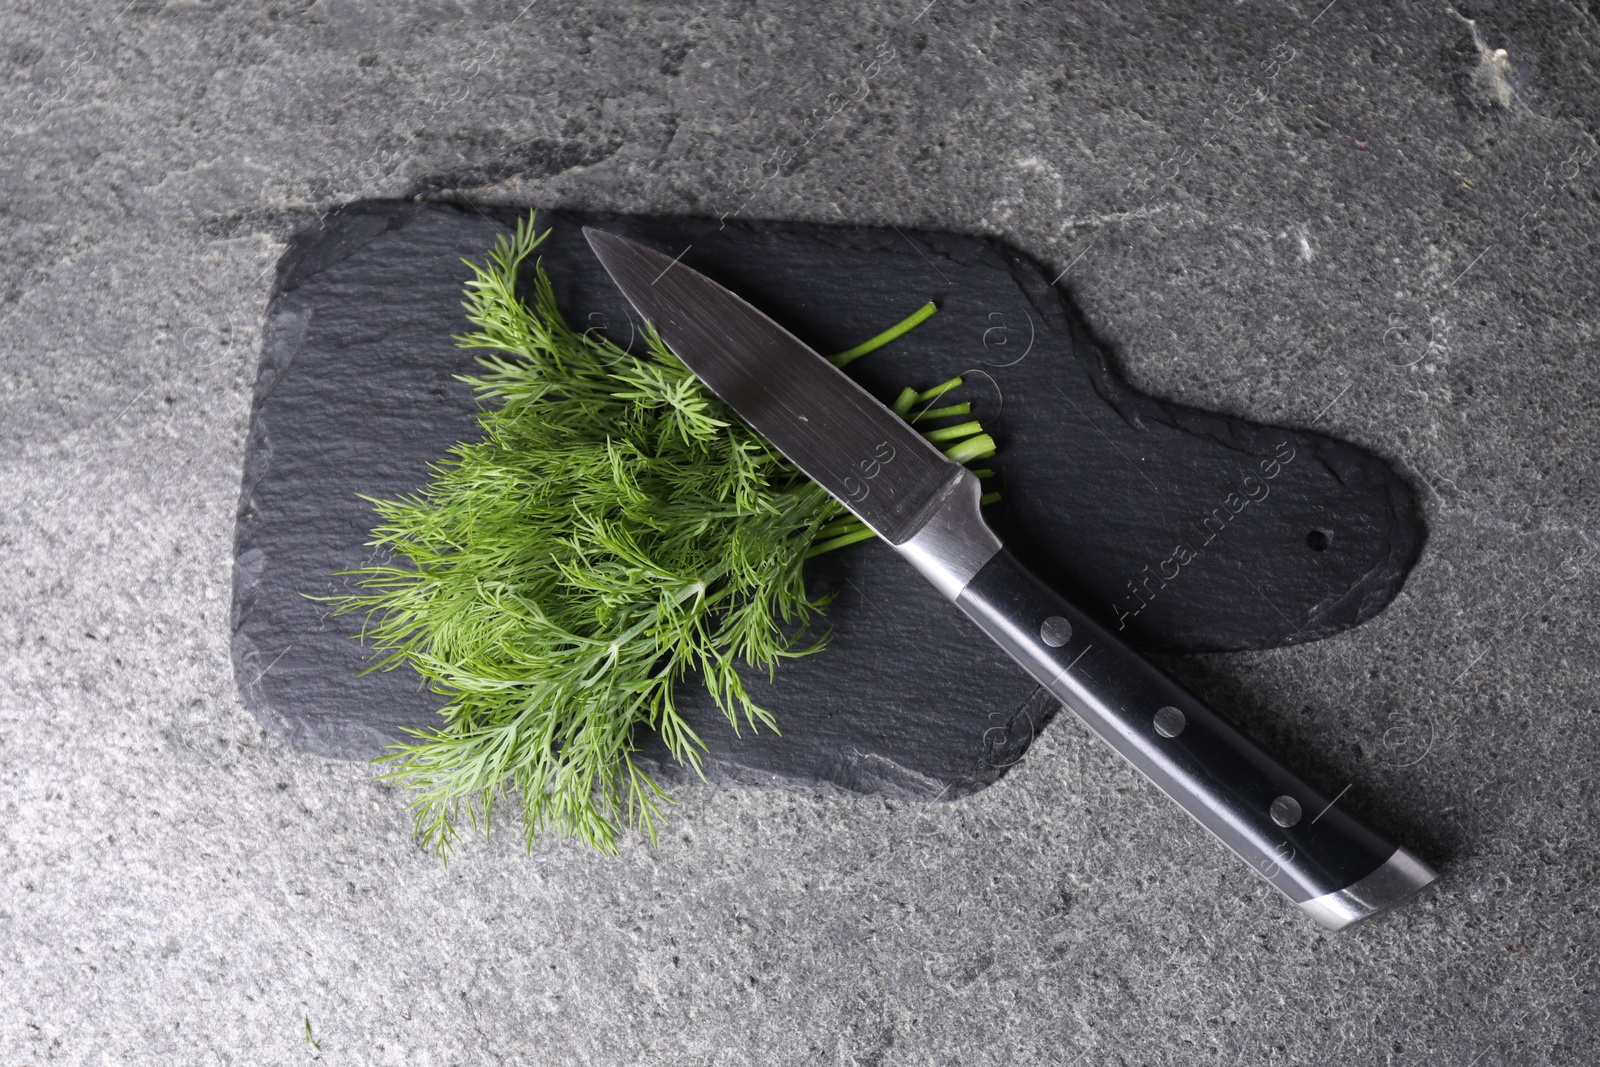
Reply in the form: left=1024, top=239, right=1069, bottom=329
left=232, top=202, right=1424, bottom=798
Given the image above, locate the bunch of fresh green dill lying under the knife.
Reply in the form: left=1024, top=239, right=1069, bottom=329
left=336, top=214, right=994, bottom=857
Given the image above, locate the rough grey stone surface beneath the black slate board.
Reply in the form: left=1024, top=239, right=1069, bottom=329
left=0, top=0, right=1600, bottom=1067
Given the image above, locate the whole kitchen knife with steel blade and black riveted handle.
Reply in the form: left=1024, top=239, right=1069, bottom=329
left=584, top=227, right=1438, bottom=929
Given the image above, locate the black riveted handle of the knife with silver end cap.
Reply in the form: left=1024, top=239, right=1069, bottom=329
left=955, top=549, right=1437, bottom=929
